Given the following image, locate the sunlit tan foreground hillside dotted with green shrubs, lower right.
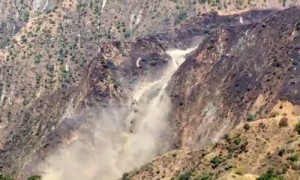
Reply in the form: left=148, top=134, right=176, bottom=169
left=127, top=102, right=300, bottom=180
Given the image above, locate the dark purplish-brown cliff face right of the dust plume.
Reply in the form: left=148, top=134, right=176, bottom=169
left=170, top=8, right=300, bottom=148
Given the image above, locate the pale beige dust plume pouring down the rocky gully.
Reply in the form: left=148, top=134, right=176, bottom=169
left=43, top=48, right=195, bottom=180
